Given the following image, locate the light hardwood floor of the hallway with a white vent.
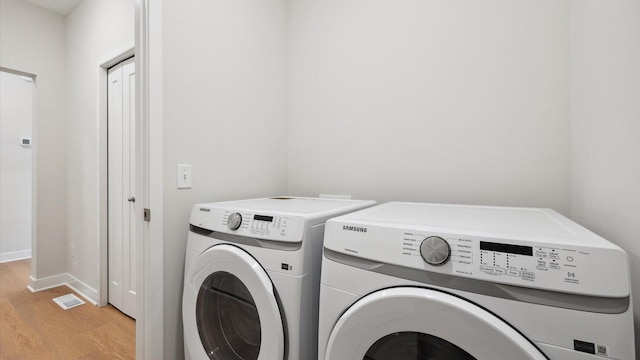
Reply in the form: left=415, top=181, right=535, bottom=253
left=0, top=260, right=136, bottom=360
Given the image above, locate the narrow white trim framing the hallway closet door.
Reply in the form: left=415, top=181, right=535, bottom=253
left=98, top=47, right=140, bottom=306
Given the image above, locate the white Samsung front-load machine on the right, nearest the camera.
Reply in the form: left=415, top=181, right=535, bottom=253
left=319, top=203, right=635, bottom=360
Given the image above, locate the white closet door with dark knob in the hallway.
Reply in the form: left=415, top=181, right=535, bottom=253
left=107, top=58, right=136, bottom=318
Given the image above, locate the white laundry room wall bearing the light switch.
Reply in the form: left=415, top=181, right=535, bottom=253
left=162, top=0, right=287, bottom=359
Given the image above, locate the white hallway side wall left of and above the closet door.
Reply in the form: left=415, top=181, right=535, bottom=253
left=65, top=0, right=135, bottom=300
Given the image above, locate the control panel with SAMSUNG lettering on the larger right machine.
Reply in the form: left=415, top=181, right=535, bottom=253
left=324, top=221, right=629, bottom=297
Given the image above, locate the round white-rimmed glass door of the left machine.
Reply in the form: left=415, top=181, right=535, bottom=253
left=182, top=245, right=284, bottom=360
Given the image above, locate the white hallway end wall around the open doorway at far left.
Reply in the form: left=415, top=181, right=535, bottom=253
left=0, top=0, right=67, bottom=280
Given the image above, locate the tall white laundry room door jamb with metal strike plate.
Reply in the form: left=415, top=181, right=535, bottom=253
left=135, top=0, right=164, bottom=359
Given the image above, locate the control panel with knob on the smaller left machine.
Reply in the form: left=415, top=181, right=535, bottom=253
left=190, top=207, right=304, bottom=242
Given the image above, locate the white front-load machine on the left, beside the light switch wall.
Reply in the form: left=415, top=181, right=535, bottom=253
left=182, top=197, right=375, bottom=360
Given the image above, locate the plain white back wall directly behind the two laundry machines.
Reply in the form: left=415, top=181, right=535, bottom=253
left=287, top=0, right=569, bottom=214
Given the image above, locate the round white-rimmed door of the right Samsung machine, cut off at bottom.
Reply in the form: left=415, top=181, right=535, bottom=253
left=325, top=287, right=547, bottom=360
